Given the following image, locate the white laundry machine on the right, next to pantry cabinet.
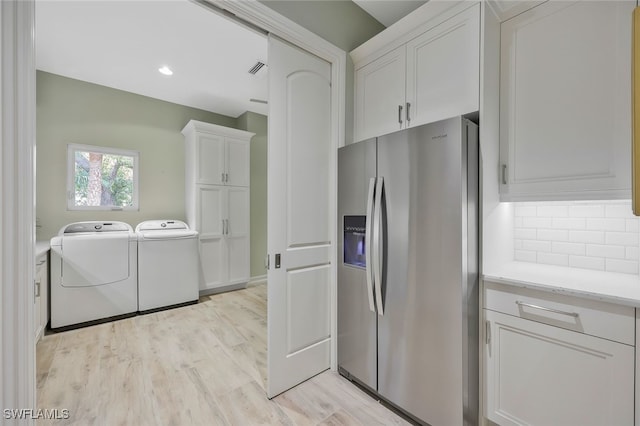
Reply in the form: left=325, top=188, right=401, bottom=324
left=136, top=220, right=199, bottom=312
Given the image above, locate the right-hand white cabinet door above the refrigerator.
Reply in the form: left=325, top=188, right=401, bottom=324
left=406, top=4, right=480, bottom=126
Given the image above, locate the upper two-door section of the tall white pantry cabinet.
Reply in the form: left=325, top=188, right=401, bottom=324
left=182, top=120, right=253, bottom=186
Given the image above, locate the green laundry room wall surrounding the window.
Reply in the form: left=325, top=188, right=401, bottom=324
left=36, top=71, right=238, bottom=240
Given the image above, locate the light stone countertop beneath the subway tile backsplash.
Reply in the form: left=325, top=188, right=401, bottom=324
left=482, top=262, right=640, bottom=308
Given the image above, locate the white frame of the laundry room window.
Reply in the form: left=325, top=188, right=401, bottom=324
left=67, top=143, right=140, bottom=211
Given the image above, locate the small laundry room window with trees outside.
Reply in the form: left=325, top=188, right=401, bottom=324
left=67, top=144, right=138, bottom=210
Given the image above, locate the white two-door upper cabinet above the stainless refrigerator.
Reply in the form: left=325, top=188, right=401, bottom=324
left=351, top=2, right=480, bottom=140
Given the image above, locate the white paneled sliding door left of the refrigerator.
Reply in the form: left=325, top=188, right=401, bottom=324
left=267, top=36, right=333, bottom=398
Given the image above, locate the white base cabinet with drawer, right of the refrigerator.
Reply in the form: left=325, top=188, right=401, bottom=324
left=484, top=282, right=635, bottom=426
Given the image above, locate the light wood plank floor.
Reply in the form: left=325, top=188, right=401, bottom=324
left=37, top=285, right=408, bottom=426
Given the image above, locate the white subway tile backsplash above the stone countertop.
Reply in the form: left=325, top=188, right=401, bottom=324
left=514, top=201, right=640, bottom=275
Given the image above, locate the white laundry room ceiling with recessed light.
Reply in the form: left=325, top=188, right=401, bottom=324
left=36, top=0, right=267, bottom=117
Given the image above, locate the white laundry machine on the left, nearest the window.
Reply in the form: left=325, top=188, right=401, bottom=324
left=51, top=222, right=138, bottom=329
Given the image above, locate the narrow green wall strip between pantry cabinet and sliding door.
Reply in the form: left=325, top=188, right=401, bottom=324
left=238, top=111, right=267, bottom=277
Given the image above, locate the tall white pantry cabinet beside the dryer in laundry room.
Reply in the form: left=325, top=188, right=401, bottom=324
left=182, top=120, right=254, bottom=293
